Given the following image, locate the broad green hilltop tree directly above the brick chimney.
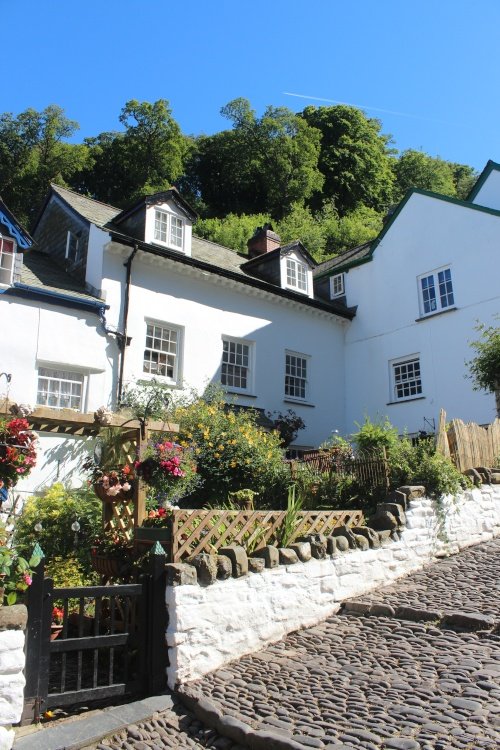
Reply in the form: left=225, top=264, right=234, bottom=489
left=191, top=98, right=323, bottom=218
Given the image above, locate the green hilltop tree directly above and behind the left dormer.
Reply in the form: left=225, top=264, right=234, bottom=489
left=79, top=99, right=189, bottom=206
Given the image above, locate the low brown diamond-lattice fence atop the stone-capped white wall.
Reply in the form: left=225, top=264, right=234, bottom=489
left=171, top=509, right=364, bottom=562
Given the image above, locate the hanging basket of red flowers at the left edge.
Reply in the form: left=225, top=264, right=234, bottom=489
left=0, top=417, right=37, bottom=489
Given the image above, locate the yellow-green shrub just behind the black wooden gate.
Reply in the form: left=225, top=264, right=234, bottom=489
left=14, top=483, right=102, bottom=577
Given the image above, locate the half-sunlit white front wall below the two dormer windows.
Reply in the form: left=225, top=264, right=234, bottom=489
left=104, top=248, right=346, bottom=446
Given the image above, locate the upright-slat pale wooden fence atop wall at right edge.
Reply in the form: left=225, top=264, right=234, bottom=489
left=437, top=409, right=500, bottom=471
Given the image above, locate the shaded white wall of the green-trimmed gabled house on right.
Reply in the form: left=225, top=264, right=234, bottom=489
left=345, top=193, right=500, bottom=432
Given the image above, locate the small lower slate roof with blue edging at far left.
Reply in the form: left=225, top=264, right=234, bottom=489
left=21, top=250, right=103, bottom=302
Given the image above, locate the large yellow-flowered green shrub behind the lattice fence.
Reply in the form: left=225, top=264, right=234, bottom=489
left=172, top=387, right=289, bottom=507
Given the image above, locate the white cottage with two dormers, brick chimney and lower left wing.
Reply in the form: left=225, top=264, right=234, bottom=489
left=0, top=186, right=354, bottom=489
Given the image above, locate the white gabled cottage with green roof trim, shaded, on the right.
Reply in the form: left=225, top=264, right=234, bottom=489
left=315, top=162, right=500, bottom=433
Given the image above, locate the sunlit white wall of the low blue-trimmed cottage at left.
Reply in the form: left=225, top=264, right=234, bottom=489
left=0, top=295, right=113, bottom=498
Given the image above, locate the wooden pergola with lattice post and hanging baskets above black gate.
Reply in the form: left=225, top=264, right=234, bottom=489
left=2, top=401, right=179, bottom=535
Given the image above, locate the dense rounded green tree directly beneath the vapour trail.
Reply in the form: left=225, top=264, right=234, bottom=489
left=302, top=104, right=394, bottom=216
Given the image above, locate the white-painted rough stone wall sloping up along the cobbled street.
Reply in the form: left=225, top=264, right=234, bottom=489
left=166, top=485, right=500, bottom=688
